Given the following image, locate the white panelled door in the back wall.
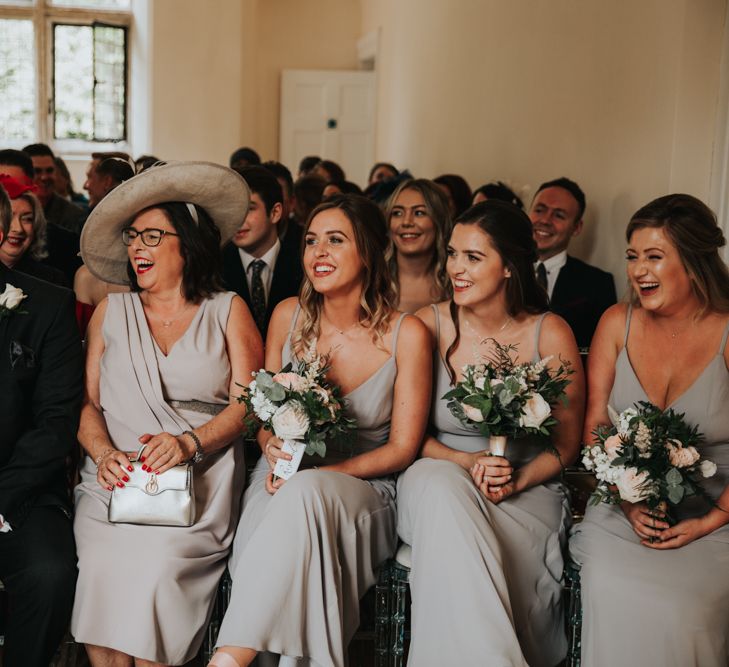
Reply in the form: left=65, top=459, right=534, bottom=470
left=279, top=70, right=375, bottom=189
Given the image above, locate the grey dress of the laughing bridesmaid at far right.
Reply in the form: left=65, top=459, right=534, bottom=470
left=570, top=310, right=729, bottom=667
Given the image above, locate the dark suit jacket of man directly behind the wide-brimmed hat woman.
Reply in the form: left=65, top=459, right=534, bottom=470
left=223, top=225, right=304, bottom=341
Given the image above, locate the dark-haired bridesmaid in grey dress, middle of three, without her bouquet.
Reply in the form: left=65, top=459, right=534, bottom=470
left=398, top=200, right=584, bottom=667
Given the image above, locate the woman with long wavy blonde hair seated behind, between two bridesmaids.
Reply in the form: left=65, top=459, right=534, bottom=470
left=385, top=178, right=451, bottom=313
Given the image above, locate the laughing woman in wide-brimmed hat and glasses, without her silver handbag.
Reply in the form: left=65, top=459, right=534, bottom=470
left=72, top=162, right=262, bottom=665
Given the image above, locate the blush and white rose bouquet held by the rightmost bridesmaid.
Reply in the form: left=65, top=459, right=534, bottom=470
left=582, top=401, right=716, bottom=520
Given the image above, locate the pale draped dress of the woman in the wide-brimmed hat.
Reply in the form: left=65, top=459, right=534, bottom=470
left=71, top=292, right=245, bottom=665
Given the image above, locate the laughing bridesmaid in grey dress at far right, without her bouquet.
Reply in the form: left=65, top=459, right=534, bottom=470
left=570, top=194, right=729, bottom=667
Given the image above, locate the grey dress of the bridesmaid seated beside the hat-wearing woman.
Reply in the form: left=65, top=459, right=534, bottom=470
left=217, top=308, right=404, bottom=667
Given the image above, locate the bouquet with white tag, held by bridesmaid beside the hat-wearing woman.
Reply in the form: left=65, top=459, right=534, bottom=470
left=238, top=350, right=355, bottom=479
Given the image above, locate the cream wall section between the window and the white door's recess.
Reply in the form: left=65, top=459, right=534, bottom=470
left=148, top=0, right=251, bottom=163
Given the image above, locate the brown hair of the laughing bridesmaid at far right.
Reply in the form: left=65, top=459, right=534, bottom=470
left=625, top=194, right=729, bottom=316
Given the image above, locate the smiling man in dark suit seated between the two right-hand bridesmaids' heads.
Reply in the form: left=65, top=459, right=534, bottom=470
left=529, top=177, right=617, bottom=348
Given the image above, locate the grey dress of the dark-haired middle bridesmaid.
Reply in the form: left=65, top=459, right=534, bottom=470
left=397, top=308, right=570, bottom=667
